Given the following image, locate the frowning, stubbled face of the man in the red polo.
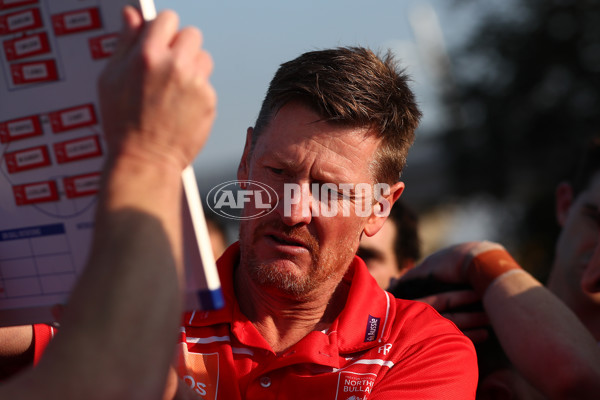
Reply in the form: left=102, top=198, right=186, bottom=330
left=238, top=102, right=394, bottom=298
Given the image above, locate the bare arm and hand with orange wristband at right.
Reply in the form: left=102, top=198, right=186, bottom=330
left=403, top=242, right=600, bottom=399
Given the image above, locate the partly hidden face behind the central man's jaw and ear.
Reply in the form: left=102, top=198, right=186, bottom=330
left=357, top=219, right=401, bottom=289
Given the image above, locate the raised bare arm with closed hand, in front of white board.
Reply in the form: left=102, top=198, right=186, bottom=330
left=0, top=7, right=216, bottom=400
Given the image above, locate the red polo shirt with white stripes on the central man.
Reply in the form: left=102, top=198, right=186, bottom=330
left=178, top=244, right=477, bottom=400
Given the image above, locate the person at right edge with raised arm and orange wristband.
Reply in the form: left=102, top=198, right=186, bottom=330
left=392, top=138, right=600, bottom=399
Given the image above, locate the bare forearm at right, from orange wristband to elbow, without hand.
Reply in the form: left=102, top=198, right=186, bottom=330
left=483, top=264, right=600, bottom=399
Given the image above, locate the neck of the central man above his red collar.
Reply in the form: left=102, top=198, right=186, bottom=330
left=234, top=268, right=349, bottom=353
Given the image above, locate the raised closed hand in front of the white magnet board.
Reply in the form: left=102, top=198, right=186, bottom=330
left=99, top=5, right=216, bottom=168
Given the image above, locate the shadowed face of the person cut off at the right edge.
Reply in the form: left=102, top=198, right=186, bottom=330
left=548, top=172, right=600, bottom=336
